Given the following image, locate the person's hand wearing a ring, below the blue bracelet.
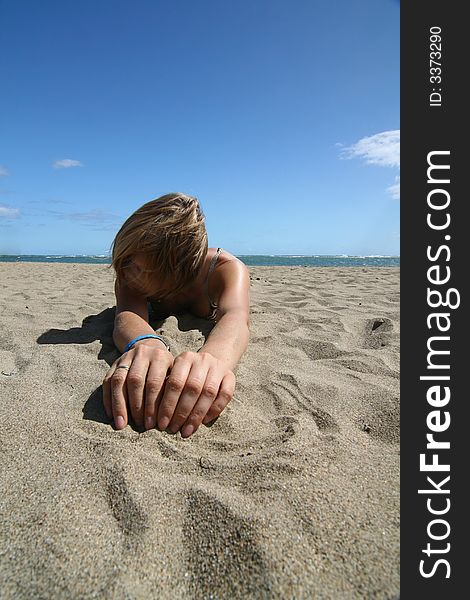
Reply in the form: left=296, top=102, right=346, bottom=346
left=103, top=340, right=174, bottom=429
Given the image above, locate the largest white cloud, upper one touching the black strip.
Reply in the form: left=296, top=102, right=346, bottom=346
left=342, top=129, right=400, bottom=167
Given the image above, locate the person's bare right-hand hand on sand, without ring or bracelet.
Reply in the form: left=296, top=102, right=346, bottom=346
left=158, top=352, right=235, bottom=437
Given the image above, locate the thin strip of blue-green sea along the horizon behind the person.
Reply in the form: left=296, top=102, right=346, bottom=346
left=0, top=254, right=400, bottom=267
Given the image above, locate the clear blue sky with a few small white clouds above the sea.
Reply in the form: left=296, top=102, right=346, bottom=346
left=0, top=0, right=400, bottom=255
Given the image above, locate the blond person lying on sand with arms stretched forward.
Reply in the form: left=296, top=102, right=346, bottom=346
left=103, top=194, right=250, bottom=437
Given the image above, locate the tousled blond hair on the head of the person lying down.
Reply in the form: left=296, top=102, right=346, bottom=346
left=111, top=193, right=207, bottom=296
